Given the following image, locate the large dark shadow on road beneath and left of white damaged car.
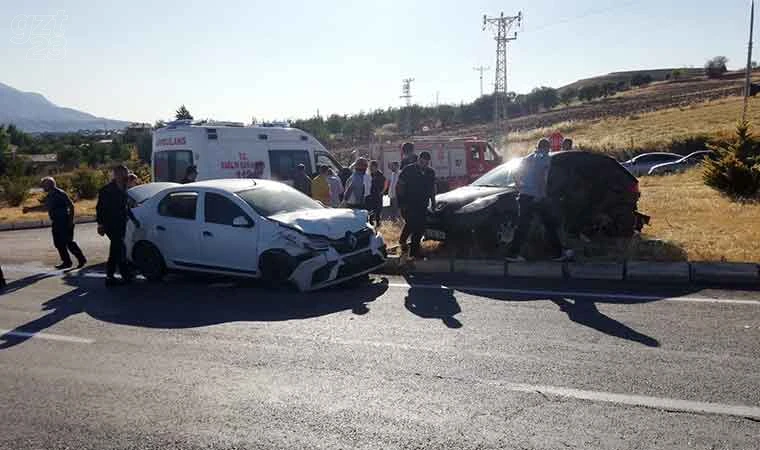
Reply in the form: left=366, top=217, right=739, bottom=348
left=0, top=271, right=388, bottom=350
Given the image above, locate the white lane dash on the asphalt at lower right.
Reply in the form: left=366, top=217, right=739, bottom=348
left=498, top=383, right=760, bottom=420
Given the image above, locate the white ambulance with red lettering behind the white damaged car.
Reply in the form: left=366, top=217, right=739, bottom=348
left=152, top=120, right=345, bottom=183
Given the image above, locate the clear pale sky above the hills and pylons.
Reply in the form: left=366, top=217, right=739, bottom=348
left=0, top=0, right=760, bottom=122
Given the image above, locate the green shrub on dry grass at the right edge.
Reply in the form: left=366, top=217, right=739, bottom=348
left=702, top=122, right=760, bottom=198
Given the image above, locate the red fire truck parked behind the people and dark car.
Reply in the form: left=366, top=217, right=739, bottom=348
left=370, top=136, right=502, bottom=192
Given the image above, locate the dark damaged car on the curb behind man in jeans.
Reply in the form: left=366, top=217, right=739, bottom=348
left=425, top=151, right=649, bottom=249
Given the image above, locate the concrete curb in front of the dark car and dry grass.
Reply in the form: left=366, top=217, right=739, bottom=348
left=380, top=256, right=760, bottom=286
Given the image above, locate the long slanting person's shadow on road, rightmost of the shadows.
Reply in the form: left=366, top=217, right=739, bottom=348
left=551, top=297, right=660, bottom=347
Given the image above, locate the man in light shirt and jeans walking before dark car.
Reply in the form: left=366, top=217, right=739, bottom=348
left=507, top=138, right=572, bottom=262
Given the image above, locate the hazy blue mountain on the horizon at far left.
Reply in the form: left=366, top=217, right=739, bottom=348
left=0, top=83, right=129, bottom=133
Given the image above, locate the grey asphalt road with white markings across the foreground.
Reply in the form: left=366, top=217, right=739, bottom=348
left=0, top=226, right=760, bottom=450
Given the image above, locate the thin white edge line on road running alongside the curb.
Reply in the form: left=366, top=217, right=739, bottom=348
left=388, top=283, right=760, bottom=306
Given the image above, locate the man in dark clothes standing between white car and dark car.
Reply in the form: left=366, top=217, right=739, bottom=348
left=396, top=152, right=435, bottom=258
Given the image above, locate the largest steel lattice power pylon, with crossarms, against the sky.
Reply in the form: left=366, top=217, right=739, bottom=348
left=483, top=12, right=522, bottom=128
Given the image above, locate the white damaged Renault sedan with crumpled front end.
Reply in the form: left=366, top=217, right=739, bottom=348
left=125, top=179, right=387, bottom=291
